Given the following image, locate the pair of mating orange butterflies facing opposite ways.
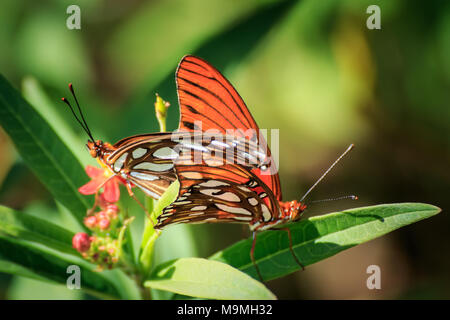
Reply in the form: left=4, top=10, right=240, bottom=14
left=63, top=56, right=352, bottom=279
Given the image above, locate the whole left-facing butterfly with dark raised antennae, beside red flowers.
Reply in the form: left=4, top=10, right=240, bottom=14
left=62, top=84, right=265, bottom=202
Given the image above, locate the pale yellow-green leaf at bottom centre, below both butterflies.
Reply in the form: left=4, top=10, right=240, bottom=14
left=145, top=258, right=276, bottom=300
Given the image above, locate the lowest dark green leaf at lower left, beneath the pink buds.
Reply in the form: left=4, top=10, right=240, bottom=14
left=0, top=236, right=122, bottom=298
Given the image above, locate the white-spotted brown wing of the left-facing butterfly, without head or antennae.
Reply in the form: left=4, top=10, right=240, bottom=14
left=105, top=132, right=267, bottom=199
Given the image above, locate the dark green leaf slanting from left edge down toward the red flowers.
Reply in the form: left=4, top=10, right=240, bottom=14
left=0, top=75, right=89, bottom=223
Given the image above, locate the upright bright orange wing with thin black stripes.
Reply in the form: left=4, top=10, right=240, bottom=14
left=176, top=55, right=282, bottom=200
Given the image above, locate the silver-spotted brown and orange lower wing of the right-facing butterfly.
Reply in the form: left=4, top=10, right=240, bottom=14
left=155, top=164, right=281, bottom=230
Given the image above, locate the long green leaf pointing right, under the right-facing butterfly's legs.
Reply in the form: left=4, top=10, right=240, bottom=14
left=210, top=203, right=441, bottom=281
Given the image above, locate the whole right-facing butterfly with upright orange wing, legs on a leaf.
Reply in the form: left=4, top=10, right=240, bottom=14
left=155, top=56, right=353, bottom=279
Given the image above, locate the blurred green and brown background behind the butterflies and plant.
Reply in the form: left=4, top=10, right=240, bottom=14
left=0, top=0, right=450, bottom=299
